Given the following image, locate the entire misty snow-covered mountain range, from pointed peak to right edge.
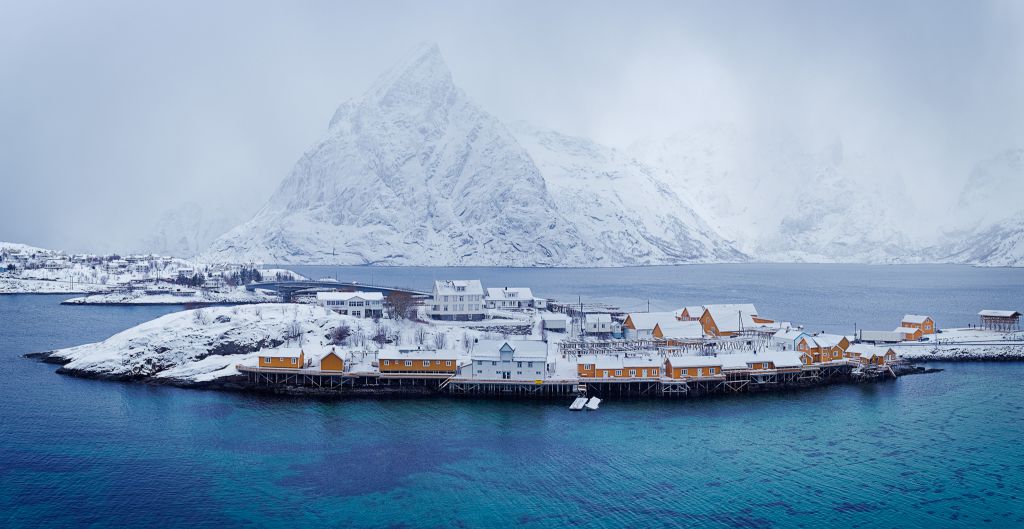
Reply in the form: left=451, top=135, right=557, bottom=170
left=199, top=45, right=1024, bottom=266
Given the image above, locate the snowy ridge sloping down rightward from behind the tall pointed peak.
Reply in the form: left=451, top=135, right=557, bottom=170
left=511, top=122, right=745, bottom=264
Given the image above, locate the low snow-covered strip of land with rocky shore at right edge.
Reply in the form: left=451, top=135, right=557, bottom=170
left=893, top=327, right=1024, bottom=361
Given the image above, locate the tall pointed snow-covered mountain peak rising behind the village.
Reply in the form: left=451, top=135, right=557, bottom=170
left=204, top=45, right=738, bottom=266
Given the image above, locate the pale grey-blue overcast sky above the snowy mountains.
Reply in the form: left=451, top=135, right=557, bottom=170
left=0, top=0, right=1024, bottom=251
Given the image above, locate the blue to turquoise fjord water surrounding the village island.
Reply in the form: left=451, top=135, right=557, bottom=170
left=0, top=266, right=1024, bottom=528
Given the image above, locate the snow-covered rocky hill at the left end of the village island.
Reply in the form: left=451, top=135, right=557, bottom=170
left=43, top=304, right=507, bottom=384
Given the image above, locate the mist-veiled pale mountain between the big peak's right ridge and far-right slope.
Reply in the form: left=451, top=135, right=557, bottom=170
left=630, top=125, right=925, bottom=263
